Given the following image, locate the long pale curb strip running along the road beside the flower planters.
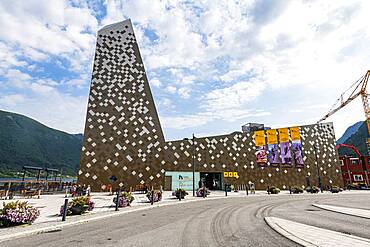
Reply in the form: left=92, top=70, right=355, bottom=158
left=0, top=196, right=237, bottom=243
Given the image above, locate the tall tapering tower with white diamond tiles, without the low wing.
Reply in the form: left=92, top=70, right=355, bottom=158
left=78, top=20, right=164, bottom=190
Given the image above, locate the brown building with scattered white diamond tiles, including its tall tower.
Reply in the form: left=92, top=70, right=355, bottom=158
left=78, top=20, right=343, bottom=191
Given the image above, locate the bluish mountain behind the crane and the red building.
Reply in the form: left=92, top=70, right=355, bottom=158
left=338, top=122, right=368, bottom=156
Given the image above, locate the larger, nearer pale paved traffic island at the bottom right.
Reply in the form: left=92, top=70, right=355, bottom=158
left=265, top=217, right=370, bottom=247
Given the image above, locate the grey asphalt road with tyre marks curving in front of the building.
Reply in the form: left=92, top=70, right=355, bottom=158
left=0, top=194, right=370, bottom=247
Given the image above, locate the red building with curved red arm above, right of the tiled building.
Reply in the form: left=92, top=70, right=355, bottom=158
left=337, top=144, right=370, bottom=187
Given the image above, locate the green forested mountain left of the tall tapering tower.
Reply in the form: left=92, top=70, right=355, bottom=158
left=0, top=111, right=83, bottom=176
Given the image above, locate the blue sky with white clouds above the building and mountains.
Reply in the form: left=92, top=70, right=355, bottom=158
left=0, top=0, right=370, bottom=140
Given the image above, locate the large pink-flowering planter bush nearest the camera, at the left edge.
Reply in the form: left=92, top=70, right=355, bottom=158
left=0, top=201, right=40, bottom=227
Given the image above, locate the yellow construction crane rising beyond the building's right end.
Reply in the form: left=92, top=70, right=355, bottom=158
left=317, top=70, right=370, bottom=155
